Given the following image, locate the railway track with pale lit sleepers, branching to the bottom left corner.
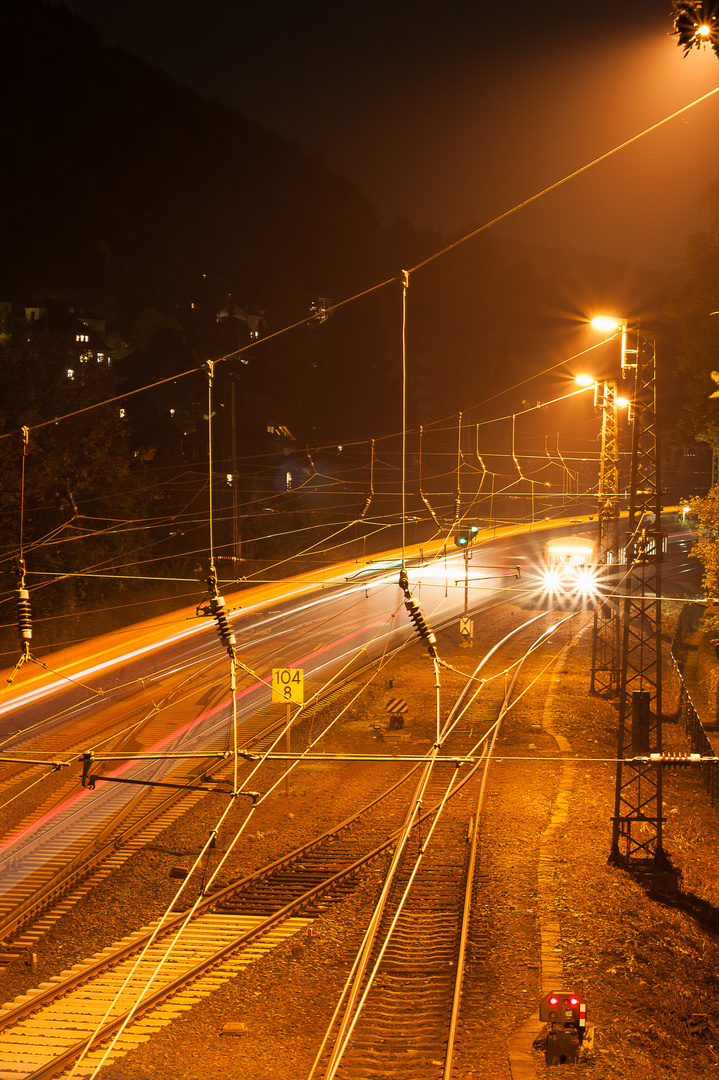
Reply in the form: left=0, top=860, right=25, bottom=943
left=0, top=764, right=453, bottom=1080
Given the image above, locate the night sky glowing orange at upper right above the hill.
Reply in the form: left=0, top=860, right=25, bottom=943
left=57, top=0, right=719, bottom=267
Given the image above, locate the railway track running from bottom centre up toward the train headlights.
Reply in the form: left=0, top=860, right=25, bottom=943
left=310, top=616, right=572, bottom=1080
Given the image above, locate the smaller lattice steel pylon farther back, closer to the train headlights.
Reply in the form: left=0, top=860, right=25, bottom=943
left=589, top=381, right=620, bottom=697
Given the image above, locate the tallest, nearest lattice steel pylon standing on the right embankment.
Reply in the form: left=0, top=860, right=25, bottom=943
left=610, top=328, right=666, bottom=870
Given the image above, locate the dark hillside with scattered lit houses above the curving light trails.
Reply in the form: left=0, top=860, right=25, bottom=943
left=0, top=6, right=690, bottom=665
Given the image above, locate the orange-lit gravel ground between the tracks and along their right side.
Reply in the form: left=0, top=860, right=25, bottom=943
left=2, top=608, right=719, bottom=1080
